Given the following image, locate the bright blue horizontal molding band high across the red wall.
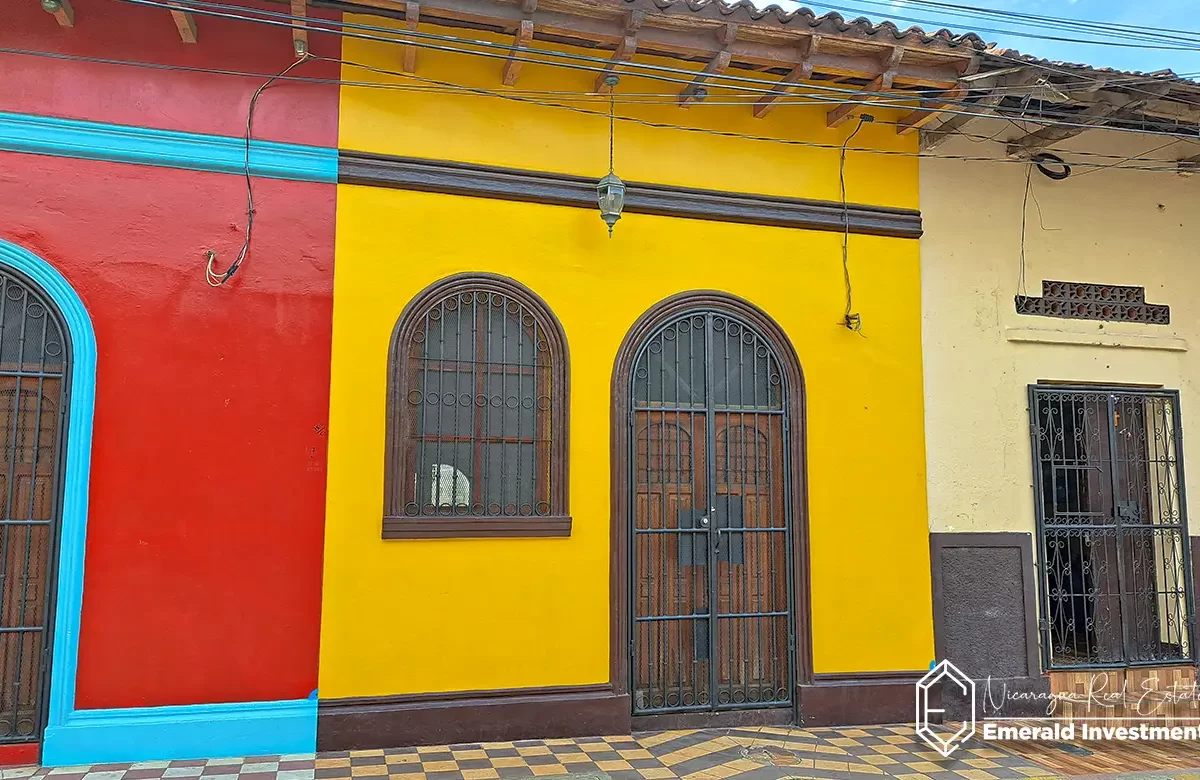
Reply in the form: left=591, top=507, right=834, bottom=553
left=0, top=112, right=337, bottom=184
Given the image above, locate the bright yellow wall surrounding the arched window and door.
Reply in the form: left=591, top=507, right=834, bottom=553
left=320, top=15, right=932, bottom=698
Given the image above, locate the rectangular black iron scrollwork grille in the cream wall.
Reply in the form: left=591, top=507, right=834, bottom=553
left=1030, top=385, right=1195, bottom=670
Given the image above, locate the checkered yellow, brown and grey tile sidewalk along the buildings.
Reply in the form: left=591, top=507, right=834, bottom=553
left=0, top=726, right=1070, bottom=780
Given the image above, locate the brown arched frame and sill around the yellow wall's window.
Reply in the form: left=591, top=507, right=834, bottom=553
left=383, top=274, right=571, bottom=539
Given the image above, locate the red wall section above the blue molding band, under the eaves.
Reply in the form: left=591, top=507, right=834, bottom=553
left=0, top=0, right=341, bottom=146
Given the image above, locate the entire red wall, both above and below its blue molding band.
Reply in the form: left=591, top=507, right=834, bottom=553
left=0, top=0, right=337, bottom=708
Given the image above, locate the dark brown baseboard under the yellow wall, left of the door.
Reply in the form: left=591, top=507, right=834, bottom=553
left=317, top=683, right=630, bottom=750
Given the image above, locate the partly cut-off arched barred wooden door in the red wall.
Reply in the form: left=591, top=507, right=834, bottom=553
left=0, top=268, right=71, bottom=743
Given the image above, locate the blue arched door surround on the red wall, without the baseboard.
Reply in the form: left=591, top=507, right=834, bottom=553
left=0, top=239, right=96, bottom=748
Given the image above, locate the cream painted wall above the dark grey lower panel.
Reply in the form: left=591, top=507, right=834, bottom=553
left=920, top=122, right=1200, bottom=534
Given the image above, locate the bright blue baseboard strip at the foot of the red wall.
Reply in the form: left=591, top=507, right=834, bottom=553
left=42, top=698, right=317, bottom=767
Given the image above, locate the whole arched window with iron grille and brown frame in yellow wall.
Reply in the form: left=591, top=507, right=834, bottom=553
left=383, top=274, right=571, bottom=539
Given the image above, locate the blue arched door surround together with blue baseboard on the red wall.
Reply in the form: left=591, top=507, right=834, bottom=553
left=0, top=240, right=317, bottom=766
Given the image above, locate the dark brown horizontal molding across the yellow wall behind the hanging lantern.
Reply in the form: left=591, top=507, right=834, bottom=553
left=337, top=150, right=922, bottom=239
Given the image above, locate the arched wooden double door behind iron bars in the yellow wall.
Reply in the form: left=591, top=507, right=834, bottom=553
left=629, top=308, right=796, bottom=715
